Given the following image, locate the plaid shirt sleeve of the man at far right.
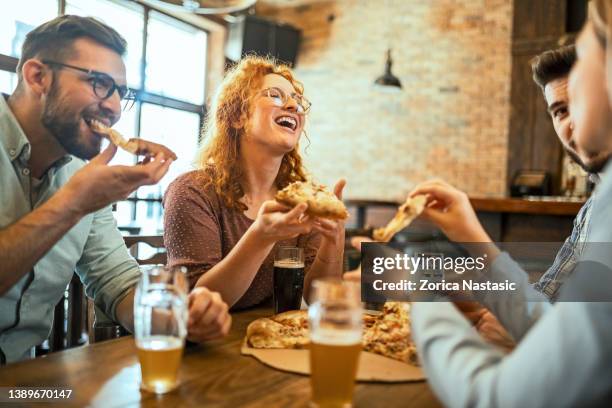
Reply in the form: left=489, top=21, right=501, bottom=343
left=534, top=198, right=592, bottom=302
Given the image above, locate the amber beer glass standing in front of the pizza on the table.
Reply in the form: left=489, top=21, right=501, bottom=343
left=308, top=279, right=363, bottom=408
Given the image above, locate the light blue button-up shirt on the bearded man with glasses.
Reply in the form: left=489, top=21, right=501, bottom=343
left=0, top=95, right=139, bottom=363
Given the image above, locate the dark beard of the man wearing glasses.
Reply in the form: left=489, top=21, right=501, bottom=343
left=41, top=81, right=102, bottom=160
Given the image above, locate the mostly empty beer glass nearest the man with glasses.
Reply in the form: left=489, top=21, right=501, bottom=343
left=134, top=266, right=189, bottom=394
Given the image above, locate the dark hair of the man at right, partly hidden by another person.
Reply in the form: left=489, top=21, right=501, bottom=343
left=531, top=45, right=576, bottom=91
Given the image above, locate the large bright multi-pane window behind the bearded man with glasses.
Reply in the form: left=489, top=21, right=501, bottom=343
left=0, top=0, right=207, bottom=234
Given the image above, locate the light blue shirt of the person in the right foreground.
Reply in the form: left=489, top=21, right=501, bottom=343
left=412, top=165, right=612, bottom=407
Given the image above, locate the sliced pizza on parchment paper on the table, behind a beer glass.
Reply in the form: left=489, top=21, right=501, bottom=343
left=246, top=302, right=418, bottom=365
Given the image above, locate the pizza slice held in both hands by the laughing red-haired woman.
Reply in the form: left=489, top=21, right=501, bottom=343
left=275, top=181, right=348, bottom=220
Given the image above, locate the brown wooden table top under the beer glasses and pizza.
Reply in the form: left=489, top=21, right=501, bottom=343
left=0, top=308, right=440, bottom=408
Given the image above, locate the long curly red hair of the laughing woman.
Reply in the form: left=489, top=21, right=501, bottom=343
left=197, top=55, right=306, bottom=211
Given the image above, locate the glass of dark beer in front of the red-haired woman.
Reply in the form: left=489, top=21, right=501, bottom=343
left=273, top=246, right=304, bottom=313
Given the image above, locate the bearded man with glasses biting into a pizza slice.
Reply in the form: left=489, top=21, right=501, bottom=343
left=0, top=16, right=231, bottom=364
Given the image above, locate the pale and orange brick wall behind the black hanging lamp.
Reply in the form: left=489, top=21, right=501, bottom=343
left=257, top=0, right=512, bottom=199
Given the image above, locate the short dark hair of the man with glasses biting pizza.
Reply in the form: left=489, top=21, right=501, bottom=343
left=17, top=15, right=127, bottom=83
